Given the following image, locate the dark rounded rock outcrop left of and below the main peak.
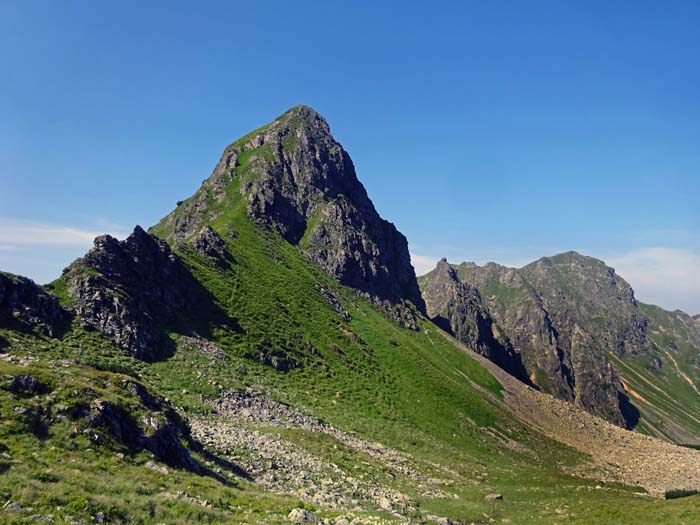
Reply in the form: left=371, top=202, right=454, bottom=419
left=63, top=226, right=194, bottom=361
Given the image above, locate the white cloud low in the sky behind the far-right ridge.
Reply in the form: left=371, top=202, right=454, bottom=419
left=606, top=246, right=700, bottom=314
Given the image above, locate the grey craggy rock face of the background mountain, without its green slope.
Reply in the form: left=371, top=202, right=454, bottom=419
left=421, top=252, right=649, bottom=427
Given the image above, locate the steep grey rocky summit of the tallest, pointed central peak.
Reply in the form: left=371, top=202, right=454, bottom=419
left=158, top=106, right=424, bottom=311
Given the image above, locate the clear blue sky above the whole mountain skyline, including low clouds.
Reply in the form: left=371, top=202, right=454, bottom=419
left=0, top=0, right=700, bottom=313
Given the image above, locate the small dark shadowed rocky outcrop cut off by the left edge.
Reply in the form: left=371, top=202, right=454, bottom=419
left=0, top=272, right=70, bottom=336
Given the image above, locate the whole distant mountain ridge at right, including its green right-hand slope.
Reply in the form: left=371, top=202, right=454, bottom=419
left=419, top=252, right=700, bottom=442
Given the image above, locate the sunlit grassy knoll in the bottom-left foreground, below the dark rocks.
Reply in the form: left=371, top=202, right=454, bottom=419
left=0, top=334, right=295, bottom=524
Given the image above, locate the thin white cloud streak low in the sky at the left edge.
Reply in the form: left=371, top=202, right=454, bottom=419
left=0, top=217, right=123, bottom=251
